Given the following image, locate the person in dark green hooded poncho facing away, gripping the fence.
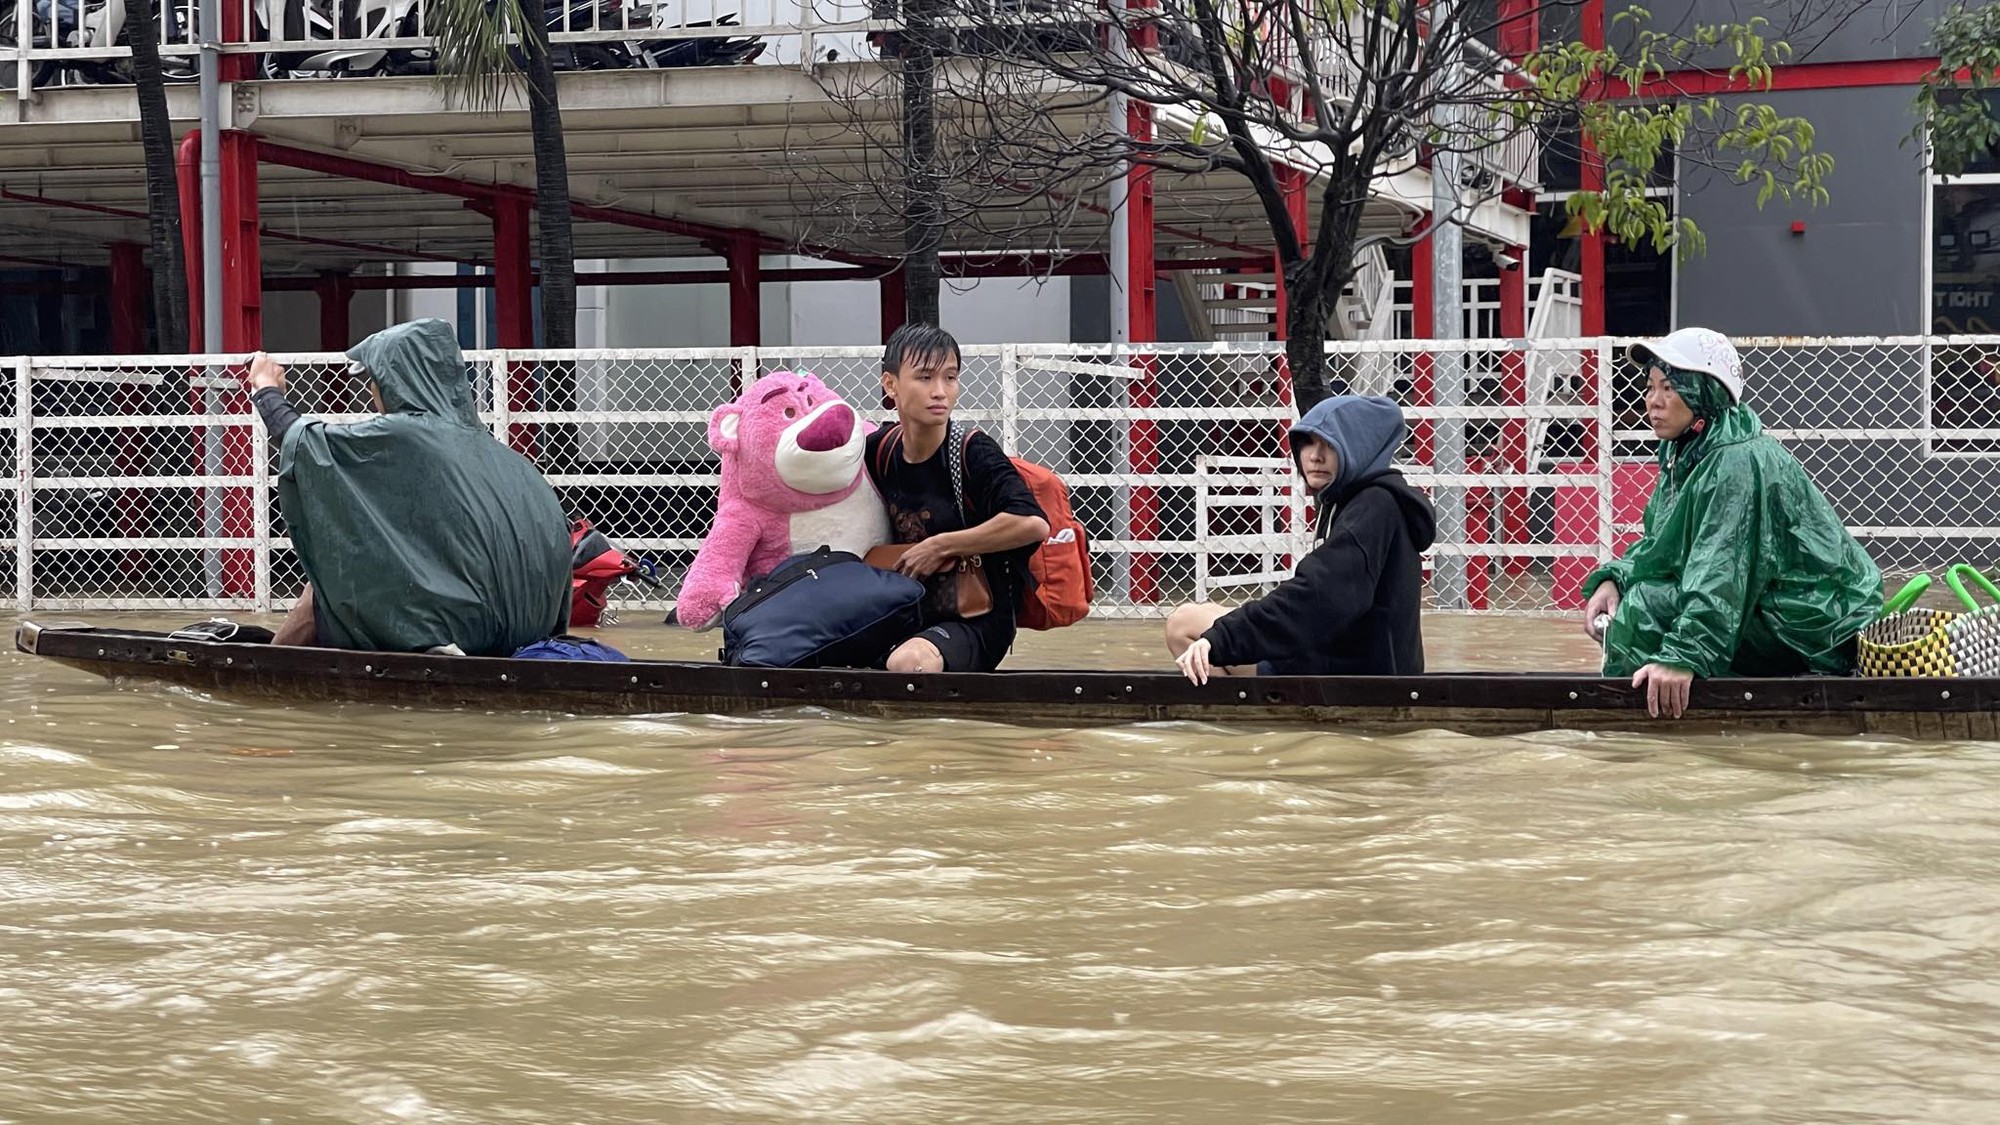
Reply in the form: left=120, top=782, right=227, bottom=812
left=244, top=320, right=570, bottom=657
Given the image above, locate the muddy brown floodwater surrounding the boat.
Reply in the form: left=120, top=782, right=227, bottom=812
left=0, top=615, right=2000, bottom=1125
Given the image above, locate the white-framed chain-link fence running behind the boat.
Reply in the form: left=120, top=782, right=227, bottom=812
left=11, top=338, right=2000, bottom=617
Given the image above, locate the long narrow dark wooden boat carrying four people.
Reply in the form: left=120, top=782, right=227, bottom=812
left=14, top=623, right=2000, bottom=741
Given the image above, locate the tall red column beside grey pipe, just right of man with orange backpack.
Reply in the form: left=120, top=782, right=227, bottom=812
left=1124, top=102, right=1160, bottom=605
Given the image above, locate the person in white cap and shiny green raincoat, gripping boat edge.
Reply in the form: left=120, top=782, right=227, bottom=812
left=1584, top=328, right=1882, bottom=719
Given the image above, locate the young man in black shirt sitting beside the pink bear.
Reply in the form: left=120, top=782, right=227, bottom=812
left=868, top=324, right=1048, bottom=673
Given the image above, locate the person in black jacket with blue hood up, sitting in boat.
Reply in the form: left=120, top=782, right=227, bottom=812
left=1166, top=394, right=1438, bottom=685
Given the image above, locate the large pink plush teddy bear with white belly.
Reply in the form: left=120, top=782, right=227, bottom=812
left=674, top=370, right=888, bottom=629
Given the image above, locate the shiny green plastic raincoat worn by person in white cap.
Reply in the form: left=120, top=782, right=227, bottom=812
left=1584, top=394, right=1882, bottom=679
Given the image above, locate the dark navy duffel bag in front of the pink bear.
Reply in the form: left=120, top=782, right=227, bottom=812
left=722, top=546, right=924, bottom=669
